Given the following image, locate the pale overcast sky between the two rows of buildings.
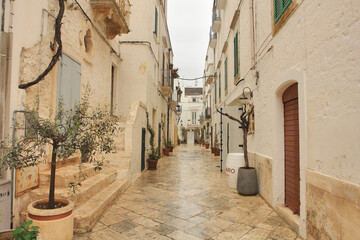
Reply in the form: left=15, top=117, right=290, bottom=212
left=168, top=0, right=213, bottom=86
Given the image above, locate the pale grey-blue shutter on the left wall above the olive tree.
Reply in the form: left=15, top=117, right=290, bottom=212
left=58, top=54, right=81, bottom=110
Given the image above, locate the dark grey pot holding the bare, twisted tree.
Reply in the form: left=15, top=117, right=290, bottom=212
left=237, top=167, right=258, bottom=196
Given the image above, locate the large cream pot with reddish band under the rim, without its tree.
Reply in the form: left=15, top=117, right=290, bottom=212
left=27, top=199, right=74, bottom=240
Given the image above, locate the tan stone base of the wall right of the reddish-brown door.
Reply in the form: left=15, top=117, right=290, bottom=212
left=306, top=170, right=360, bottom=240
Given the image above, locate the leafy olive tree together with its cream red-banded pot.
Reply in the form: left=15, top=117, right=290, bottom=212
left=0, top=91, right=117, bottom=239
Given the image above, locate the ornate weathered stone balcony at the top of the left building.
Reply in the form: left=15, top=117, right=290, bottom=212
left=90, top=0, right=130, bottom=39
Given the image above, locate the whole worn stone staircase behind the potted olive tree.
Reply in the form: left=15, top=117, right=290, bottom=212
left=31, top=122, right=131, bottom=233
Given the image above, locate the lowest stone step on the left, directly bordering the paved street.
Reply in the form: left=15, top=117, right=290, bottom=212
left=74, top=179, right=129, bottom=233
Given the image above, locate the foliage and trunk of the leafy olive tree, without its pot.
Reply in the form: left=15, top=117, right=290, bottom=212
left=0, top=89, right=117, bottom=209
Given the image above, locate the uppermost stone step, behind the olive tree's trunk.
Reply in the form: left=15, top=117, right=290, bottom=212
left=40, top=163, right=99, bottom=188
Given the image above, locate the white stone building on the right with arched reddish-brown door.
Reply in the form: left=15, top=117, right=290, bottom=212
left=205, top=0, right=360, bottom=239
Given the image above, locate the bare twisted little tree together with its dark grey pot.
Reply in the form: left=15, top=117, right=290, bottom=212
left=216, top=103, right=258, bottom=195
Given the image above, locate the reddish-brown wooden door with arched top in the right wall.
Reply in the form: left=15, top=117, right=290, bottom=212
left=282, top=83, right=300, bottom=214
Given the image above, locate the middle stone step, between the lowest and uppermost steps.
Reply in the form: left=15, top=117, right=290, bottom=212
left=31, top=170, right=117, bottom=206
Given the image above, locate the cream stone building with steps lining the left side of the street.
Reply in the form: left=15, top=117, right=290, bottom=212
left=0, top=0, right=177, bottom=232
